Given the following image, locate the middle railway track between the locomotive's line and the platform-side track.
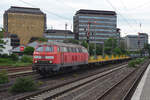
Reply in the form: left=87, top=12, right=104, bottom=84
left=17, top=64, right=127, bottom=100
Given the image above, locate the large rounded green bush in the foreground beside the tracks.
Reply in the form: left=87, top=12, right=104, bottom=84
left=10, top=77, right=37, bottom=93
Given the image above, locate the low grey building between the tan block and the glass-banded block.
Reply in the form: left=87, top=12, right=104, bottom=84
left=44, top=29, right=74, bottom=42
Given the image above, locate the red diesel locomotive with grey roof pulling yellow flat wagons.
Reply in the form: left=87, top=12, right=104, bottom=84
left=32, top=42, right=88, bottom=75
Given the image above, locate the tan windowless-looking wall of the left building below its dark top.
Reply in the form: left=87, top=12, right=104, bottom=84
left=5, top=13, right=45, bottom=45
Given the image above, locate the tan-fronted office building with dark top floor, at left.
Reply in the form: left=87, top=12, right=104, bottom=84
left=3, top=6, right=46, bottom=45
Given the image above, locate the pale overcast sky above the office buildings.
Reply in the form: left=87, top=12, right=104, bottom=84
left=0, top=0, right=150, bottom=36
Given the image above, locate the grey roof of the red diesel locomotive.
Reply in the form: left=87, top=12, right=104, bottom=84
left=41, top=42, right=84, bottom=48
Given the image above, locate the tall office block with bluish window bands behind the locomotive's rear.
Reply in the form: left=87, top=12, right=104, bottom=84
left=73, top=9, right=120, bottom=43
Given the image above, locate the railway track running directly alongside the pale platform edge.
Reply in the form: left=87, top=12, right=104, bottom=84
left=96, top=61, right=149, bottom=100
